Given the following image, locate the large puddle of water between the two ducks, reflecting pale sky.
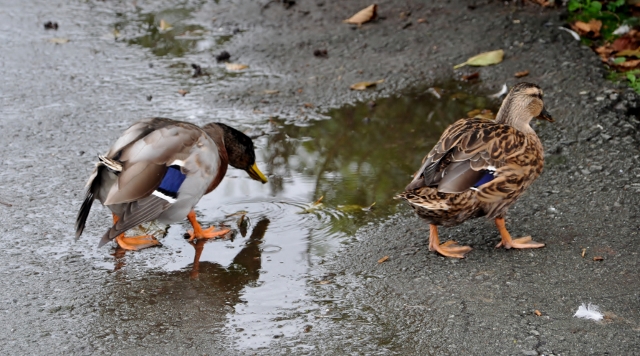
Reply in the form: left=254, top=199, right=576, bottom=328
left=86, top=82, right=495, bottom=348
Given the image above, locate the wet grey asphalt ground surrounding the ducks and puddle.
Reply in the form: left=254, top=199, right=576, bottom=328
left=0, top=0, right=640, bottom=355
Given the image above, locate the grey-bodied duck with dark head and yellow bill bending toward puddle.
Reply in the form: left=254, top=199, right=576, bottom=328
left=76, top=118, right=267, bottom=250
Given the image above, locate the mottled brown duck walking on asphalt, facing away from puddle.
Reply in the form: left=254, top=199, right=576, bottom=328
left=397, top=83, right=553, bottom=258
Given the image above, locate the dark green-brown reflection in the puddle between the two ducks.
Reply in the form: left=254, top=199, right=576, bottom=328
left=263, top=82, right=493, bottom=233
